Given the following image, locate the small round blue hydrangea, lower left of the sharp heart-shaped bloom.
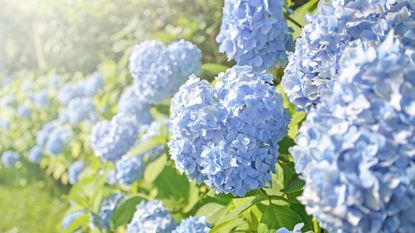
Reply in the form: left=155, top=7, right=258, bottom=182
left=115, top=155, right=144, bottom=185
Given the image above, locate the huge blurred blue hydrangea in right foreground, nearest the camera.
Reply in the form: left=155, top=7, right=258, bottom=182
left=290, top=34, right=415, bottom=232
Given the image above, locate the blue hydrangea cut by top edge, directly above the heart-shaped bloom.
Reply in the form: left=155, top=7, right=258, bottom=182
left=216, top=0, right=293, bottom=71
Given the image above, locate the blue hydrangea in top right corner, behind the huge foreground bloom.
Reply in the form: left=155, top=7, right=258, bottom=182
left=282, top=0, right=415, bottom=111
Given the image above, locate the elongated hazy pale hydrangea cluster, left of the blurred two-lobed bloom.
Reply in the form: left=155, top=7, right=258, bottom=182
left=58, top=72, right=104, bottom=105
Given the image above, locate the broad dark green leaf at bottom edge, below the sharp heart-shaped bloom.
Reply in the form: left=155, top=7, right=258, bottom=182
left=258, top=204, right=303, bottom=233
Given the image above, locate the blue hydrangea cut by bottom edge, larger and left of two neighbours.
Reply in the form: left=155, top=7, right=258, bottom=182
left=125, top=200, right=176, bottom=233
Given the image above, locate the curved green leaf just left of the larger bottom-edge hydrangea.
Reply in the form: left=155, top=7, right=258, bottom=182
left=111, top=196, right=143, bottom=228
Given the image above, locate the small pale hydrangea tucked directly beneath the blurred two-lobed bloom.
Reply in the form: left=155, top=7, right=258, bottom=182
left=118, top=86, right=151, bottom=124
